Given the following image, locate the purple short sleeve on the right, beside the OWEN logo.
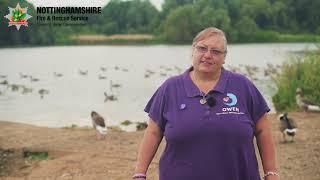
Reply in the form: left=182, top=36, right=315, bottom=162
left=247, top=80, right=270, bottom=124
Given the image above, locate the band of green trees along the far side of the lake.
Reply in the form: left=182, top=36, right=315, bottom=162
left=0, top=0, right=320, bottom=46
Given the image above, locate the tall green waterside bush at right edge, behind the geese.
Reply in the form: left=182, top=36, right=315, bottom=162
left=272, top=47, right=320, bottom=111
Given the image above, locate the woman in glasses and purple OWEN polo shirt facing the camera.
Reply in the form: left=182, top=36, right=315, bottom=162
left=133, top=27, right=279, bottom=180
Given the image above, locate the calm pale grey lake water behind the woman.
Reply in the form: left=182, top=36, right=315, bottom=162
left=0, top=43, right=314, bottom=127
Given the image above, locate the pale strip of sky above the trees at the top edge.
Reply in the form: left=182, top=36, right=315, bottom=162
left=27, top=0, right=164, bottom=9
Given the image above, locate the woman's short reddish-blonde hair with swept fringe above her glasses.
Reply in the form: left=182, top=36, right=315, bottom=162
left=192, top=27, right=227, bottom=52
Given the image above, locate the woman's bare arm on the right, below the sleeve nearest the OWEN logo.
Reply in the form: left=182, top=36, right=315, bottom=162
left=255, top=114, right=280, bottom=180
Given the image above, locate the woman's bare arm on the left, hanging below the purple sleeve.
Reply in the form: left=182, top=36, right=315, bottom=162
left=135, top=119, right=163, bottom=177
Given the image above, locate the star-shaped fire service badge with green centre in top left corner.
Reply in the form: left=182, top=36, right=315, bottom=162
left=4, top=3, right=32, bottom=30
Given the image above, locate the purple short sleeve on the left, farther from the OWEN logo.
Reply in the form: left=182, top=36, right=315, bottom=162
left=144, top=83, right=166, bottom=132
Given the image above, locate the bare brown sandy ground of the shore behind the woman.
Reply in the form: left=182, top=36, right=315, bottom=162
left=0, top=112, right=320, bottom=180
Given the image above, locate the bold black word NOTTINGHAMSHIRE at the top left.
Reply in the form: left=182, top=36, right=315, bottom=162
left=37, top=7, right=101, bottom=14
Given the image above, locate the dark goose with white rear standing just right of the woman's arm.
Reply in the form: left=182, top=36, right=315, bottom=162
left=278, top=113, right=298, bottom=142
